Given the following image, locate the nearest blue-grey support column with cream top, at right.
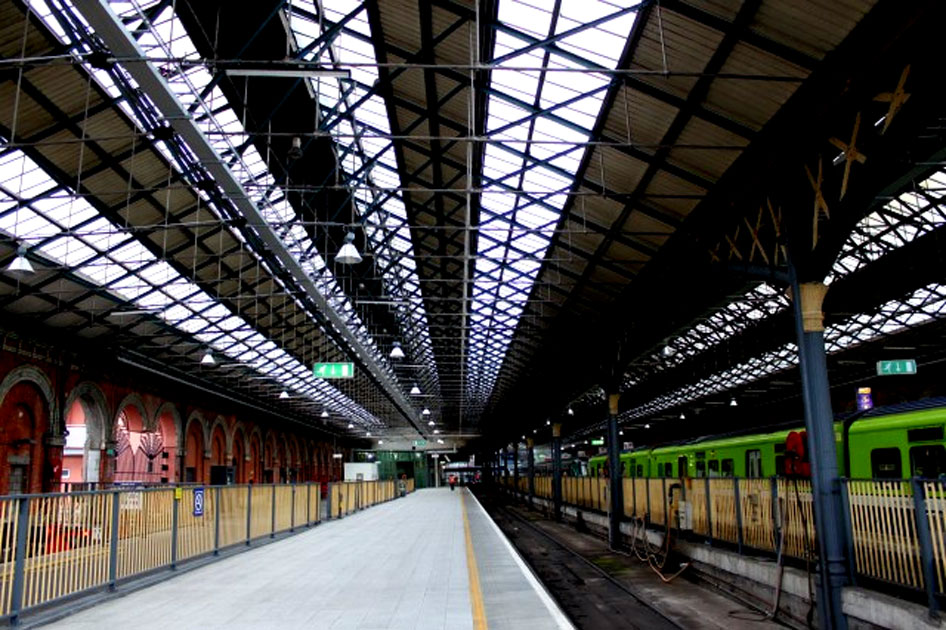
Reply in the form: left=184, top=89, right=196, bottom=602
left=792, top=280, right=849, bottom=630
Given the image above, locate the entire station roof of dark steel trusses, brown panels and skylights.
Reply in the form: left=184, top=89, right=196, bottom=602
left=0, top=0, right=946, bottom=448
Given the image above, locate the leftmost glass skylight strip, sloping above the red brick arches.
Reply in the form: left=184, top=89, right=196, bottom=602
left=0, top=143, right=378, bottom=426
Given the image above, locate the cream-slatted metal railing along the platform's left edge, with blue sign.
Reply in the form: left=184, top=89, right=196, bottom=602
left=0, top=480, right=413, bottom=623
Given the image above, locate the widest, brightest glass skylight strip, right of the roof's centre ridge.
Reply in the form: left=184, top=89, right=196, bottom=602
left=466, top=0, right=636, bottom=414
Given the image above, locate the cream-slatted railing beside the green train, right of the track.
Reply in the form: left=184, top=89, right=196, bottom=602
left=512, top=476, right=946, bottom=612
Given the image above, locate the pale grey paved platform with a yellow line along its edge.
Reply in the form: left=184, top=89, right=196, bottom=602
left=35, top=488, right=572, bottom=630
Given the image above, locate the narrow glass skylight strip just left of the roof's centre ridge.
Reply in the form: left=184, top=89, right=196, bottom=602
left=287, top=0, right=438, bottom=404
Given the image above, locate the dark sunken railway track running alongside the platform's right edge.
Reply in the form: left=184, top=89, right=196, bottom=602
left=477, top=494, right=683, bottom=630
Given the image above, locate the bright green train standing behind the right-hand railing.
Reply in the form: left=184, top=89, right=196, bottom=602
left=588, top=398, right=946, bottom=479
